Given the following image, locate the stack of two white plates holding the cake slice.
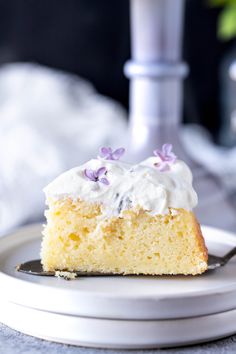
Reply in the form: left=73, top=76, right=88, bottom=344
left=0, top=225, right=236, bottom=348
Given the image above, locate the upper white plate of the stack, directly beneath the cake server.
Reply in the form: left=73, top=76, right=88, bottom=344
left=0, top=225, right=236, bottom=320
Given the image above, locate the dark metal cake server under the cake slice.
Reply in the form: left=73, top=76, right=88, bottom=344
left=16, top=247, right=236, bottom=277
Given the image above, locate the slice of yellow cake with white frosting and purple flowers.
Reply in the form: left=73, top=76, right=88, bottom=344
left=41, top=144, right=207, bottom=275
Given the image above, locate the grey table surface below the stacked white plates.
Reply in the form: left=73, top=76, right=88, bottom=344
left=0, top=324, right=236, bottom=354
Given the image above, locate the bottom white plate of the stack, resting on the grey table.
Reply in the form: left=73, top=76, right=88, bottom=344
left=0, top=302, right=236, bottom=349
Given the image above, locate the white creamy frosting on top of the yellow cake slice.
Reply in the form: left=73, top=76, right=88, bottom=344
left=44, top=157, right=197, bottom=216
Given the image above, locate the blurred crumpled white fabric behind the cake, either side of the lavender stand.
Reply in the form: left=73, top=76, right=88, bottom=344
left=0, top=63, right=236, bottom=234
